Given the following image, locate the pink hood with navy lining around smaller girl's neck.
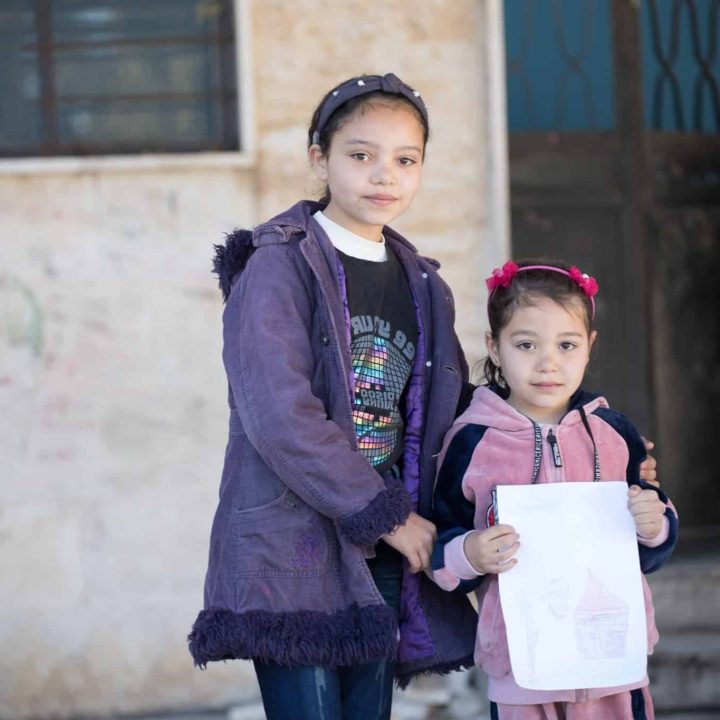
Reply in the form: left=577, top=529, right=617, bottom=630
left=453, top=386, right=608, bottom=432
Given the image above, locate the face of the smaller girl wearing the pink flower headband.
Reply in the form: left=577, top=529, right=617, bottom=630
left=485, top=297, right=596, bottom=424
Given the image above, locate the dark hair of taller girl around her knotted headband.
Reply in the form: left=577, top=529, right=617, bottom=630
left=308, top=75, right=430, bottom=203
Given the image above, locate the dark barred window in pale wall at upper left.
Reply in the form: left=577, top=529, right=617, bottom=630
left=0, top=0, right=240, bottom=157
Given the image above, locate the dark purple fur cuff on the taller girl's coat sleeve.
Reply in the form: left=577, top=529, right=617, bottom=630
left=338, top=478, right=412, bottom=545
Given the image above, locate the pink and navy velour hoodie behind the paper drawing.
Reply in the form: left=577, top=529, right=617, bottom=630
left=428, top=387, right=674, bottom=705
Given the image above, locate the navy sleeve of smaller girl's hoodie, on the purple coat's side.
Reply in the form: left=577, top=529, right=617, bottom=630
left=432, top=425, right=487, bottom=594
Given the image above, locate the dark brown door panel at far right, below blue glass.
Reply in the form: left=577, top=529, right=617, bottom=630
left=648, top=133, right=720, bottom=536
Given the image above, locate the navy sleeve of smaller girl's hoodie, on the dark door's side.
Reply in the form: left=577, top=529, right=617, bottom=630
left=593, top=408, right=678, bottom=575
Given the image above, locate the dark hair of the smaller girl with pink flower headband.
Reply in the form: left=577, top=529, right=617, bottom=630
left=483, top=258, right=595, bottom=392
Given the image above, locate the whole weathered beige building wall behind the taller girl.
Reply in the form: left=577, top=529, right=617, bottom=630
left=0, top=0, right=507, bottom=718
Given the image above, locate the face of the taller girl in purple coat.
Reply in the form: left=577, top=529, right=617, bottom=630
left=309, top=105, right=423, bottom=242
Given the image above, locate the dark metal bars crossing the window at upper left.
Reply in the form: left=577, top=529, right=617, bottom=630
left=5, top=0, right=239, bottom=156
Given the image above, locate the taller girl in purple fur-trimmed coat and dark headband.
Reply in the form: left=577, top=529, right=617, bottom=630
left=189, top=74, right=476, bottom=720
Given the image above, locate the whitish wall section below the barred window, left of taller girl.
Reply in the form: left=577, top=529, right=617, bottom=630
left=0, top=169, right=254, bottom=718
